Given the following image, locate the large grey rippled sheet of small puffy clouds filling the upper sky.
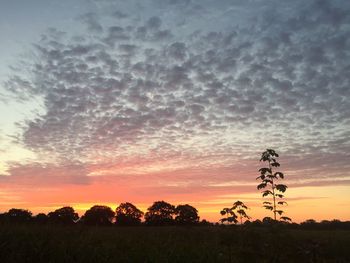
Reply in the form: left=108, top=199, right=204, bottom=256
left=2, top=1, right=350, bottom=191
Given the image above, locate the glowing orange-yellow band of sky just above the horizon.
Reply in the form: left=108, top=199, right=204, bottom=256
left=0, top=179, right=350, bottom=223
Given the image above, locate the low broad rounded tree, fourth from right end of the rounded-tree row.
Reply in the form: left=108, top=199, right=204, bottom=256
left=80, top=205, right=114, bottom=226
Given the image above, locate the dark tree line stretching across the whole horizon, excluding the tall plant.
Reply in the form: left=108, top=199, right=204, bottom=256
left=0, top=206, right=350, bottom=230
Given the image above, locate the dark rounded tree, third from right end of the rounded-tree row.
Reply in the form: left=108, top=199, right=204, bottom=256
left=115, top=202, right=143, bottom=226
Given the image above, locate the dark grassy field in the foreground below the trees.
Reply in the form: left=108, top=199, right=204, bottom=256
left=0, top=225, right=350, bottom=263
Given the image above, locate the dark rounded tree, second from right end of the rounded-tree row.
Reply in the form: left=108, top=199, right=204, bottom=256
left=145, top=201, right=175, bottom=225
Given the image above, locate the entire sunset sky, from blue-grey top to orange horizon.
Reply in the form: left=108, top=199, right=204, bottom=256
left=0, top=0, right=350, bottom=222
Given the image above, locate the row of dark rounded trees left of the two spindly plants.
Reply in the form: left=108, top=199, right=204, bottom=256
left=0, top=201, right=208, bottom=226
